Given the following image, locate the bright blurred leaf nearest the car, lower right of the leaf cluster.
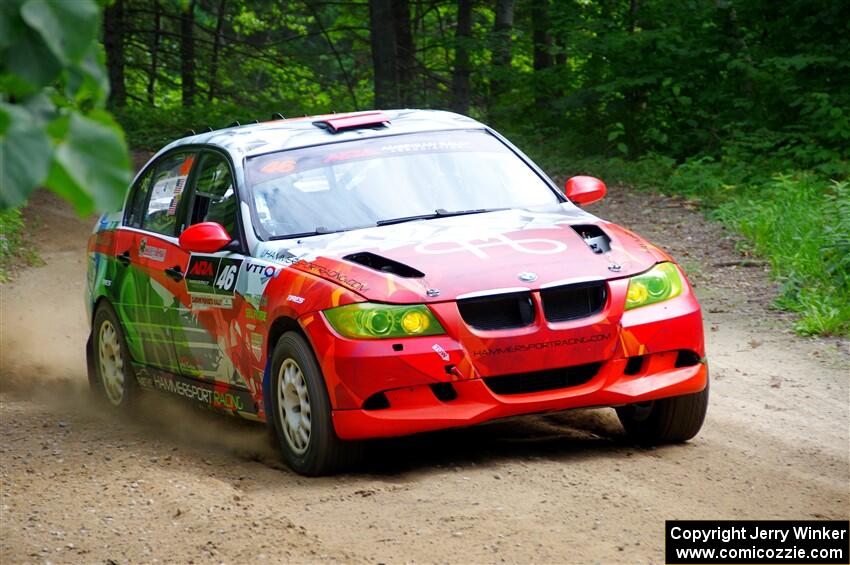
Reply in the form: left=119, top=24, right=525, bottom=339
left=47, top=112, right=130, bottom=215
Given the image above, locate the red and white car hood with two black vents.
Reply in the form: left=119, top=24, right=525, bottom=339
left=256, top=203, right=669, bottom=303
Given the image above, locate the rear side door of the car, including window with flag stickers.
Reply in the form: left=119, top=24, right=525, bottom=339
left=113, top=151, right=197, bottom=372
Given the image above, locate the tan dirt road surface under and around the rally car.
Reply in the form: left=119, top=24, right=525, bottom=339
left=0, top=189, right=850, bottom=564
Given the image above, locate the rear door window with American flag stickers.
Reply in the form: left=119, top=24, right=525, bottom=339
left=142, top=153, right=195, bottom=235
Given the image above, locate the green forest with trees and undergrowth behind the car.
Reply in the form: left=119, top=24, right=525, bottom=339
left=0, top=0, right=850, bottom=335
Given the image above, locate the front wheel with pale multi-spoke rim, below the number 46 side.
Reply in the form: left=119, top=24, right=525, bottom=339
left=269, top=332, right=362, bottom=477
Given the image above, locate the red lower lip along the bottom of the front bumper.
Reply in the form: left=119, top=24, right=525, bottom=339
left=333, top=360, right=708, bottom=440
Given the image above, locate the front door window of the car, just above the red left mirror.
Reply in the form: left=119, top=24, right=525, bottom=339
left=191, top=153, right=239, bottom=239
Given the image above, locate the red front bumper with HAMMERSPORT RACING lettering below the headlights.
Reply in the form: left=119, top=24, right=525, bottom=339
left=301, top=280, right=708, bottom=439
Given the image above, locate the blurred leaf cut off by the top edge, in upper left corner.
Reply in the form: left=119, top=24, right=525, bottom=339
left=21, top=0, right=99, bottom=65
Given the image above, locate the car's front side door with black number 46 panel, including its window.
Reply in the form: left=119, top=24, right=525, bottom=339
left=174, top=150, right=254, bottom=396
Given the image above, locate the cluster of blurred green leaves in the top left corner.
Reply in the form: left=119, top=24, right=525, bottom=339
left=0, top=0, right=130, bottom=214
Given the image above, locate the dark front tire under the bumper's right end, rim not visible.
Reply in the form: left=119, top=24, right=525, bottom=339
left=617, top=382, right=708, bottom=445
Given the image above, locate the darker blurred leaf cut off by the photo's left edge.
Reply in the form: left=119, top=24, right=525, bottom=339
left=0, top=103, right=52, bottom=209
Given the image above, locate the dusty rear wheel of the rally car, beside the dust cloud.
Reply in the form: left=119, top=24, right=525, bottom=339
left=90, top=302, right=140, bottom=412
